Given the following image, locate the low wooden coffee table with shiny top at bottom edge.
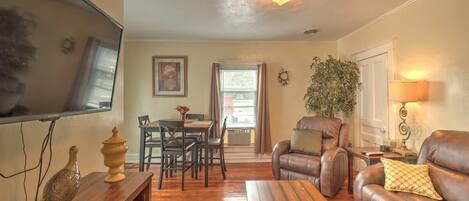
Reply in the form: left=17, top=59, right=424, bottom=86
left=246, top=180, right=326, bottom=201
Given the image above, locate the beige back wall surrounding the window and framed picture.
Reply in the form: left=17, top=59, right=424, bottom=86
left=124, top=41, right=337, bottom=156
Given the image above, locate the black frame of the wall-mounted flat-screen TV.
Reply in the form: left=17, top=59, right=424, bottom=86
left=0, top=0, right=124, bottom=124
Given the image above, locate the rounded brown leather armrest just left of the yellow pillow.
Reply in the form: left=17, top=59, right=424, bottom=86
left=353, top=163, right=385, bottom=201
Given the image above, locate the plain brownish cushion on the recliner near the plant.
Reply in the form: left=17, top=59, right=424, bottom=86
left=290, top=129, right=322, bottom=156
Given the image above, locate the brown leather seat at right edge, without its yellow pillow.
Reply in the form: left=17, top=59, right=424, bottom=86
left=353, top=130, right=469, bottom=201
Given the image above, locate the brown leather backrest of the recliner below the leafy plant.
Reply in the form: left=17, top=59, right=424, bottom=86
left=296, top=116, right=348, bottom=151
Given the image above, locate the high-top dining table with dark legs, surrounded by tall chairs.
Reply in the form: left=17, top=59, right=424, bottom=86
left=138, top=120, right=215, bottom=187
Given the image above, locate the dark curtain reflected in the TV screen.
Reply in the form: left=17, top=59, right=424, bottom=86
left=66, top=37, right=101, bottom=110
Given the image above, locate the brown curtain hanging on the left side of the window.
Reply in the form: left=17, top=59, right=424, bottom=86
left=209, top=63, right=221, bottom=137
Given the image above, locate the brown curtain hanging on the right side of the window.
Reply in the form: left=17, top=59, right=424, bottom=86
left=255, top=63, right=272, bottom=154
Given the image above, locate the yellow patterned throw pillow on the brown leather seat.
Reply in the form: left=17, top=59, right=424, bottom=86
left=381, top=158, right=443, bottom=200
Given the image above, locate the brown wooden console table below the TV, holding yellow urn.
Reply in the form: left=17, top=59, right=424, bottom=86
left=73, top=172, right=153, bottom=201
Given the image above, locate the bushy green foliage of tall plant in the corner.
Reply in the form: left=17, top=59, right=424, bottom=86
left=304, top=55, right=361, bottom=118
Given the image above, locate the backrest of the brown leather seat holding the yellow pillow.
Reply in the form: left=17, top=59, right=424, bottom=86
left=417, top=130, right=469, bottom=200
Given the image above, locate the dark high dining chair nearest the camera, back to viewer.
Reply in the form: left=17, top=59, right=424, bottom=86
left=158, top=120, right=198, bottom=191
